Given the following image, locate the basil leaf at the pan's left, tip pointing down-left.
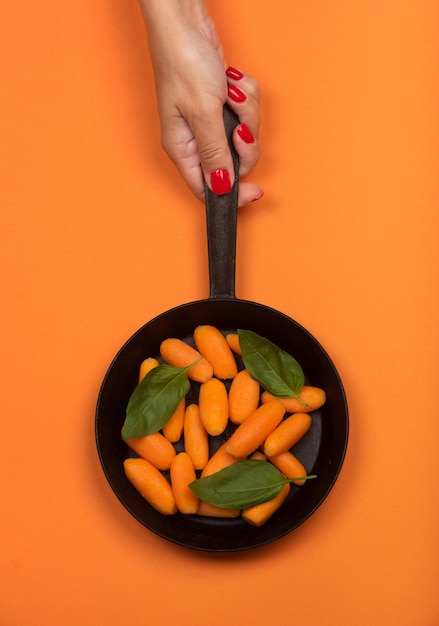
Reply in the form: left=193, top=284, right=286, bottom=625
left=122, top=363, right=194, bottom=440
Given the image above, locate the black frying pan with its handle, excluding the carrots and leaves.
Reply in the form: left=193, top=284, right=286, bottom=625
left=95, top=106, right=348, bottom=552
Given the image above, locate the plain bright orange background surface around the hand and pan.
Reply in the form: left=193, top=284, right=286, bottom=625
left=0, top=0, right=439, bottom=626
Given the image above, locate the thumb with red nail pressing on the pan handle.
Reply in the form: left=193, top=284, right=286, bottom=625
left=191, top=103, right=235, bottom=195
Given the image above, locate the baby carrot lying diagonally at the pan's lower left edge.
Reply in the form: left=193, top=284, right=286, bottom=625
left=123, top=458, right=177, bottom=515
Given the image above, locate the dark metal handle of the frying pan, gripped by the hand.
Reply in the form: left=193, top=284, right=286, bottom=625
left=205, top=104, right=239, bottom=298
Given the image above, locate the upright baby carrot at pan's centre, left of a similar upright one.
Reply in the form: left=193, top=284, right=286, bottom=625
left=198, top=378, right=229, bottom=436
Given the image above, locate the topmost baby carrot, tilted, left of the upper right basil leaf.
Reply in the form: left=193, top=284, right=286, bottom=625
left=194, top=324, right=238, bottom=379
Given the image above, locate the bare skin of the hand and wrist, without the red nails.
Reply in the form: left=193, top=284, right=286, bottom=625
left=140, top=0, right=263, bottom=206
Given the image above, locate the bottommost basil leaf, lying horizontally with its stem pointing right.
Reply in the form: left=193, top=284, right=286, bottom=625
left=189, top=459, right=315, bottom=509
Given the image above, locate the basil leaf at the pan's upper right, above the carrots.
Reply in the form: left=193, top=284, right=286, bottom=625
left=238, top=329, right=305, bottom=398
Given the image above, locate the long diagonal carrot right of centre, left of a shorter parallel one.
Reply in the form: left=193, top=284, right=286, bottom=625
left=226, top=400, right=285, bottom=459
